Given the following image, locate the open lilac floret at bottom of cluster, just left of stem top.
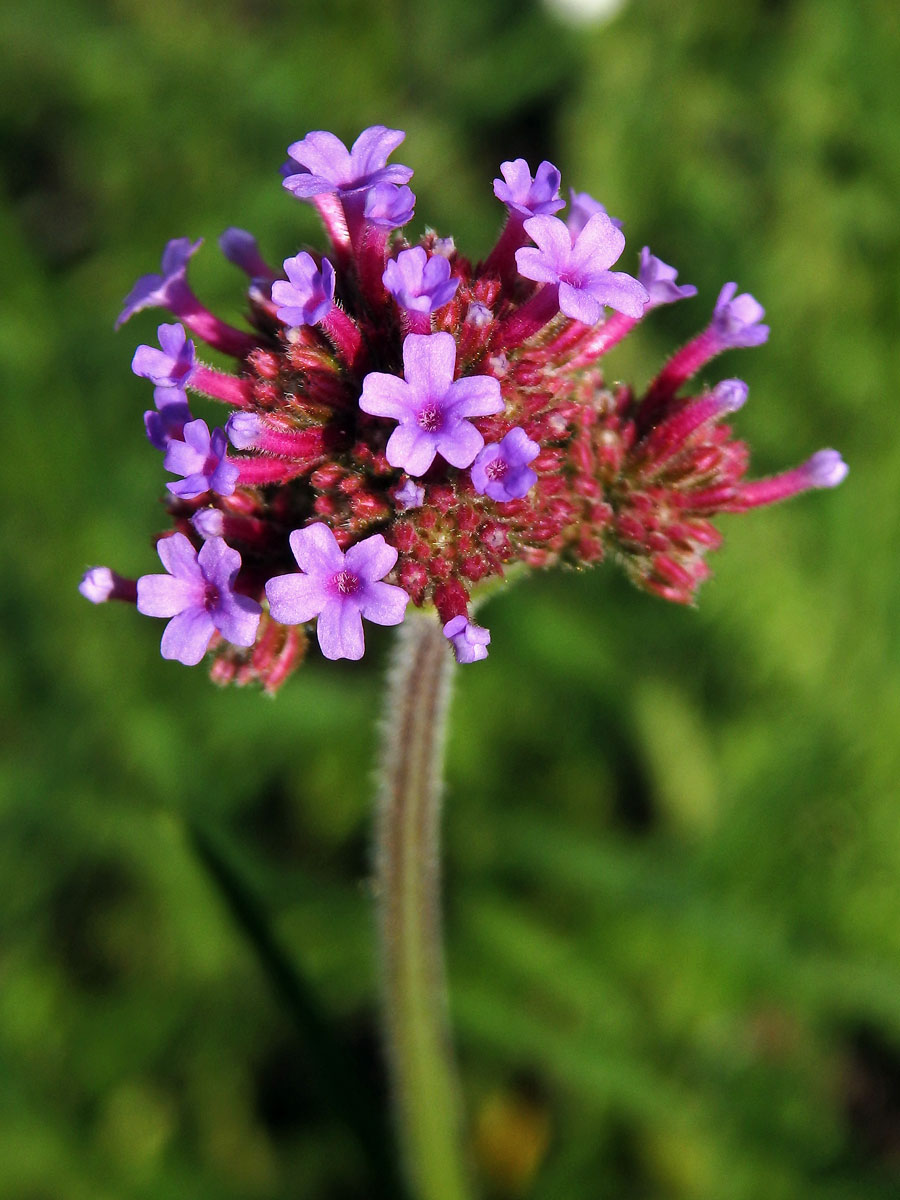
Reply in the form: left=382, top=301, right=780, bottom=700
left=265, top=522, right=409, bottom=659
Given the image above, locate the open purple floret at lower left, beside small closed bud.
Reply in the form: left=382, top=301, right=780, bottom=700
left=138, top=533, right=263, bottom=667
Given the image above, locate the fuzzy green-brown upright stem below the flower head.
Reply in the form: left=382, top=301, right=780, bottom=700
left=377, top=613, right=472, bottom=1200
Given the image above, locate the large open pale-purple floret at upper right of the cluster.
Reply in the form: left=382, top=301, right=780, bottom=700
left=516, top=212, right=649, bottom=325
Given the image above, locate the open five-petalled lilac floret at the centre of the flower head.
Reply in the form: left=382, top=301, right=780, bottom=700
left=359, top=333, right=508, bottom=475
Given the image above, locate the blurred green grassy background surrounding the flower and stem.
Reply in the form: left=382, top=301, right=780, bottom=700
left=0, top=0, right=900, bottom=1200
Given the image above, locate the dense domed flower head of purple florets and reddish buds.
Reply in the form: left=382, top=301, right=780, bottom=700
left=80, top=126, right=847, bottom=691
